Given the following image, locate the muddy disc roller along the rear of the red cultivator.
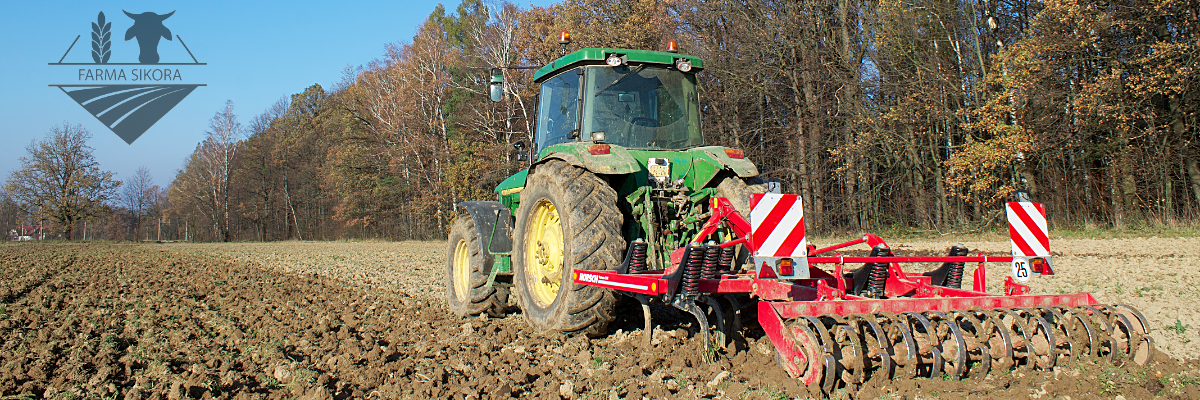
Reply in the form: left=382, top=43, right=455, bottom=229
left=776, top=304, right=1153, bottom=393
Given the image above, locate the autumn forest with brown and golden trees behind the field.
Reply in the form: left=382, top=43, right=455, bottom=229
left=0, top=0, right=1200, bottom=241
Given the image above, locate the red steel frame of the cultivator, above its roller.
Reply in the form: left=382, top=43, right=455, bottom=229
left=574, top=197, right=1096, bottom=320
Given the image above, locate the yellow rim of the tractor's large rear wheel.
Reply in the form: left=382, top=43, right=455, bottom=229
left=524, top=199, right=564, bottom=308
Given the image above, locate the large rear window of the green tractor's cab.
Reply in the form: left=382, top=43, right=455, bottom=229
left=582, top=66, right=703, bottom=149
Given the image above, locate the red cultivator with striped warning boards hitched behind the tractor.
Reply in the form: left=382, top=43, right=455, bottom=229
left=574, top=195, right=1153, bottom=392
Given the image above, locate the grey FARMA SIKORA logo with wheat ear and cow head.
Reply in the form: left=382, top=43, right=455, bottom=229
left=49, top=10, right=208, bottom=144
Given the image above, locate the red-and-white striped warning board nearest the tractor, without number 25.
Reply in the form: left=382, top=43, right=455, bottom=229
left=750, top=193, right=808, bottom=257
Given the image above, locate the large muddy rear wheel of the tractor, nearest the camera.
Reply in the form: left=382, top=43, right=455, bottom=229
left=512, top=161, right=626, bottom=336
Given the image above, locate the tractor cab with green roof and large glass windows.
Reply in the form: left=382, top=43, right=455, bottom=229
left=493, top=48, right=703, bottom=154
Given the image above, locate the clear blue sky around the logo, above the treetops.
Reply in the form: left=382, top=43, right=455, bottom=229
left=0, top=0, right=556, bottom=186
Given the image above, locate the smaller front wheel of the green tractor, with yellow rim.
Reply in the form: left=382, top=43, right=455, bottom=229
left=446, top=215, right=509, bottom=317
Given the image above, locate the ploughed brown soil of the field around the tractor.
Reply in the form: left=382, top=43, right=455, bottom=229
left=0, top=243, right=1200, bottom=399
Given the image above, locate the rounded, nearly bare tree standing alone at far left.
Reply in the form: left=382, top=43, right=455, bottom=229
left=5, top=124, right=121, bottom=240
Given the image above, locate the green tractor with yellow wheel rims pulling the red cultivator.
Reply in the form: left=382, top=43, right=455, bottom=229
left=446, top=38, right=764, bottom=336
